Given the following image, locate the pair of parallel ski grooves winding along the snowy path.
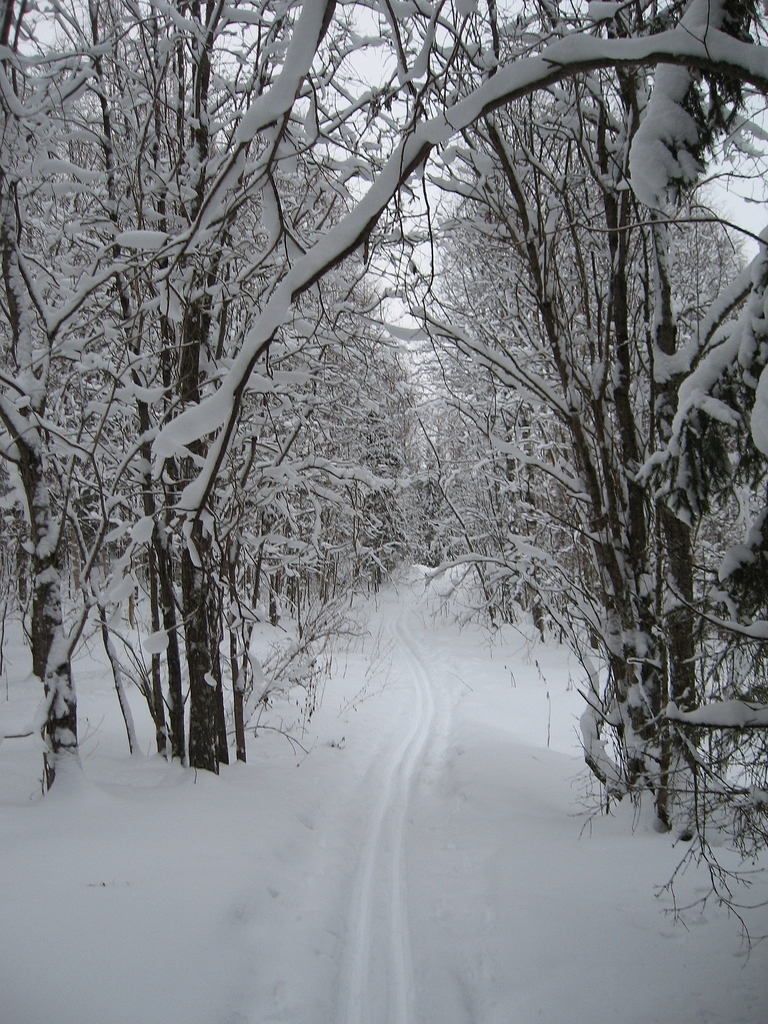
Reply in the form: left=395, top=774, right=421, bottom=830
left=339, top=609, right=435, bottom=1024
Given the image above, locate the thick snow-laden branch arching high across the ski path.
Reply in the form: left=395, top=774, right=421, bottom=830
left=154, top=19, right=768, bottom=514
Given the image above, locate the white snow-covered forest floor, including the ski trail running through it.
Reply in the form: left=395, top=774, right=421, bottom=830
left=0, top=585, right=768, bottom=1024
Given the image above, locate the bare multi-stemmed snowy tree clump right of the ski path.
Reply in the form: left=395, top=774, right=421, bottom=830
left=414, top=7, right=765, bottom=830
